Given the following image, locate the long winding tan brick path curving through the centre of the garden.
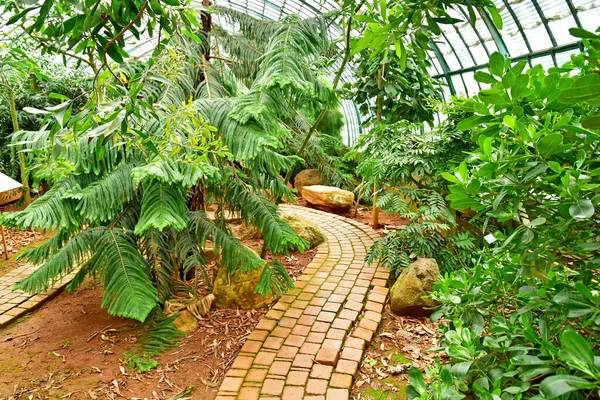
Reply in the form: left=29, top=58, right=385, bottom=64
left=217, top=206, right=389, bottom=400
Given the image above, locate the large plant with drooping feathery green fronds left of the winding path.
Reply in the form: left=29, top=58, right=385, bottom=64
left=2, top=8, right=346, bottom=328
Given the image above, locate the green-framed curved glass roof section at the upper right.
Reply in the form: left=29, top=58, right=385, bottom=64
left=429, top=0, right=600, bottom=96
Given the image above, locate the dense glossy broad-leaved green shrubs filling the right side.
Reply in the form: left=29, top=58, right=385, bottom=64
left=408, top=30, right=600, bottom=399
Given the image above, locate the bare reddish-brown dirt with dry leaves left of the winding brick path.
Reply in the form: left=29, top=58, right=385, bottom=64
left=0, top=219, right=316, bottom=400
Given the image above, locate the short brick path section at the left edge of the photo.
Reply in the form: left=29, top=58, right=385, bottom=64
left=0, top=264, right=75, bottom=328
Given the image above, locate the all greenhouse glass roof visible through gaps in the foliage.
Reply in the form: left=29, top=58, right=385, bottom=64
left=203, top=0, right=600, bottom=143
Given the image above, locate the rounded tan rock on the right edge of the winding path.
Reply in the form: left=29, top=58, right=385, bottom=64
left=390, top=258, right=440, bottom=317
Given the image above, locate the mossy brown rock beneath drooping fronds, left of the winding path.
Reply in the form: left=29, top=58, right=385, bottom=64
left=213, top=266, right=275, bottom=310
